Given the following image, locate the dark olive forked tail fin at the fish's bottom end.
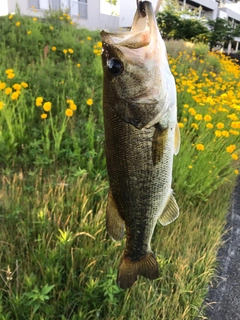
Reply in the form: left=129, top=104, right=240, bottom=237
left=117, top=252, right=159, bottom=289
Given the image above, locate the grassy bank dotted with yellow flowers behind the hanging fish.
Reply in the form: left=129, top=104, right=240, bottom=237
left=0, top=14, right=240, bottom=320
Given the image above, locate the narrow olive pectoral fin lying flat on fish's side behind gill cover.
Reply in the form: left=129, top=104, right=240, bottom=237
left=152, top=123, right=167, bottom=166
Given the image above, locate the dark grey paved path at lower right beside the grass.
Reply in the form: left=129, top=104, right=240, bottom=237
left=203, top=176, right=240, bottom=320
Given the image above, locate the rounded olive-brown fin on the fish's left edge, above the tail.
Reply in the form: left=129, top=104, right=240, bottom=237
left=106, top=189, right=124, bottom=240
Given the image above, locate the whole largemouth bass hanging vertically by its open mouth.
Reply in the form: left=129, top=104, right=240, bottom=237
left=100, top=1, right=180, bottom=289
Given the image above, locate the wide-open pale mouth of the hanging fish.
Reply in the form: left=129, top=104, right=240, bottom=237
left=101, top=1, right=159, bottom=49
